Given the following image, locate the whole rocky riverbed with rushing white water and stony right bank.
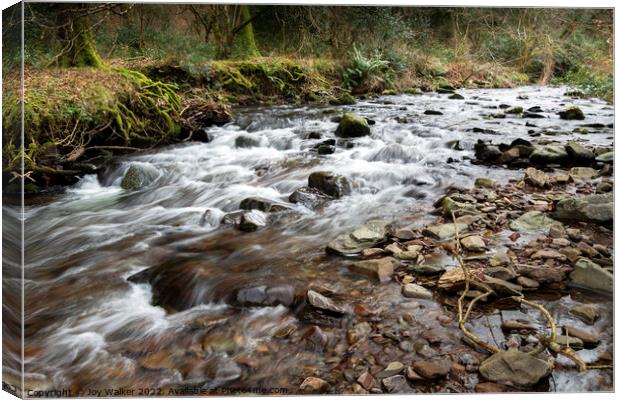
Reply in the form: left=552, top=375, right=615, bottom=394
left=4, top=87, right=614, bottom=395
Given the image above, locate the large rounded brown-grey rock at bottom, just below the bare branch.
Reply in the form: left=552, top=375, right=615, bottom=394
left=479, top=349, right=552, bottom=386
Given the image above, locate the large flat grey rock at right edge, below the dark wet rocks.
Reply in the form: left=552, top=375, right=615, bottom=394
left=553, top=193, right=614, bottom=225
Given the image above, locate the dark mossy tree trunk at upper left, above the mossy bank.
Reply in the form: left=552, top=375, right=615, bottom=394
left=57, top=3, right=104, bottom=68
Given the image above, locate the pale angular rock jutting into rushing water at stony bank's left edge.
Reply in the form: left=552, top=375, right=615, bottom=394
left=326, top=220, right=389, bottom=256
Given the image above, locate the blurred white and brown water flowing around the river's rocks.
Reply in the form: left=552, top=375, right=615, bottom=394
left=4, top=87, right=613, bottom=395
